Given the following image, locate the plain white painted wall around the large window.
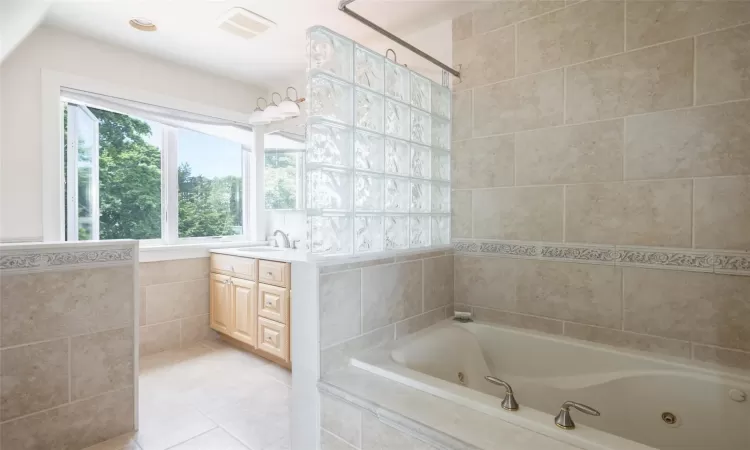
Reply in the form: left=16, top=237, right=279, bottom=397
left=0, top=26, right=264, bottom=240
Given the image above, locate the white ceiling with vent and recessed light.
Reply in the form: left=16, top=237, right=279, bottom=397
left=44, top=0, right=472, bottom=87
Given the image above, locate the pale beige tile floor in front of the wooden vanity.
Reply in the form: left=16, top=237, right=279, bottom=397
left=86, top=341, right=291, bottom=450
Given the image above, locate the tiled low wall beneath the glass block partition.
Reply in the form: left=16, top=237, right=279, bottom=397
left=319, top=250, right=454, bottom=374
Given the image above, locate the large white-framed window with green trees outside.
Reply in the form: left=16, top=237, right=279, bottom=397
left=63, top=96, right=251, bottom=243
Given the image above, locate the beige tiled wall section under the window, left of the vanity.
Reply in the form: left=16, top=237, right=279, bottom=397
left=140, top=257, right=216, bottom=355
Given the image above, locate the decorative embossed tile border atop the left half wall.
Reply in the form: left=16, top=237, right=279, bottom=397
left=0, top=247, right=134, bottom=271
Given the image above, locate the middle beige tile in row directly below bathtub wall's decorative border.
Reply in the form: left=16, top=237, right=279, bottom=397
left=515, top=260, right=622, bottom=328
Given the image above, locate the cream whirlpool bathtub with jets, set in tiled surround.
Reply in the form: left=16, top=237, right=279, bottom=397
left=351, top=321, right=750, bottom=450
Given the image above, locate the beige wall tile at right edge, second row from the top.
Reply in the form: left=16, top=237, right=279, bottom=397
left=695, top=24, right=750, bottom=105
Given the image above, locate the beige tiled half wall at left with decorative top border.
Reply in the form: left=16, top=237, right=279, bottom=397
left=0, top=241, right=138, bottom=450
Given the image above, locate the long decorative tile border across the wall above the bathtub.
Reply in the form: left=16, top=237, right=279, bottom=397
left=453, top=240, right=750, bottom=276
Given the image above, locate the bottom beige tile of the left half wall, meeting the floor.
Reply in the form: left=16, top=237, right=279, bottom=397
left=2, top=388, right=135, bottom=450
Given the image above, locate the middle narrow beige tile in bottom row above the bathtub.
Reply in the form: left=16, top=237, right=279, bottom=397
left=565, top=322, right=690, bottom=359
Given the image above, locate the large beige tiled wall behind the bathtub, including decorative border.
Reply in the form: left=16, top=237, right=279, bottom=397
left=452, top=0, right=750, bottom=369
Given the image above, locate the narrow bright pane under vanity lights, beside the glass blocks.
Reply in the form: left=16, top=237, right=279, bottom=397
left=263, top=133, right=305, bottom=210
